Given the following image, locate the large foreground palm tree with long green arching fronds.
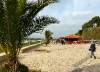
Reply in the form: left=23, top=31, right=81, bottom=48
left=0, top=0, right=59, bottom=69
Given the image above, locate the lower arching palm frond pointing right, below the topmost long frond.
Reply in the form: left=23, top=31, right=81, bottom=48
left=21, top=16, right=59, bottom=37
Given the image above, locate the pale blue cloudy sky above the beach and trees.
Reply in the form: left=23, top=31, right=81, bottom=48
left=30, top=0, right=100, bottom=38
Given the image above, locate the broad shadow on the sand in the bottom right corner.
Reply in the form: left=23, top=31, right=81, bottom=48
left=71, top=64, right=100, bottom=72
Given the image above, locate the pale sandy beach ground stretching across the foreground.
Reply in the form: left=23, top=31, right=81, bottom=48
left=19, top=44, right=100, bottom=72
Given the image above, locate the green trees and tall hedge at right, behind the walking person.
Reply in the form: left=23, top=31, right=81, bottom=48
left=76, top=16, right=100, bottom=40
